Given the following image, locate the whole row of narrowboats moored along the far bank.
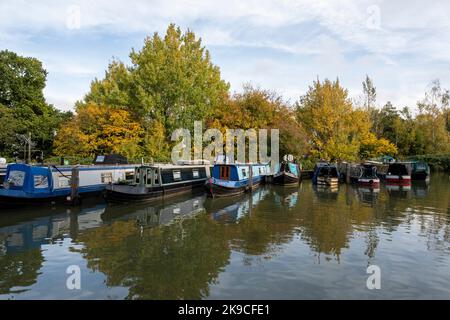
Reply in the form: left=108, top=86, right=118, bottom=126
left=0, top=155, right=430, bottom=206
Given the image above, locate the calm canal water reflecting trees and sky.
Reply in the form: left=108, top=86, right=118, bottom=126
left=0, top=174, right=450, bottom=299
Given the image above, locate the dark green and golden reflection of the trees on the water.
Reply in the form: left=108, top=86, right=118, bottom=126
left=0, top=176, right=450, bottom=299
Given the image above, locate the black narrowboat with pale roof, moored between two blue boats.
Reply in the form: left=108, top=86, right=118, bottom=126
left=105, top=164, right=210, bottom=202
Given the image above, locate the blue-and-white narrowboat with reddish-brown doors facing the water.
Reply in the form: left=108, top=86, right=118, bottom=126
left=206, top=163, right=270, bottom=197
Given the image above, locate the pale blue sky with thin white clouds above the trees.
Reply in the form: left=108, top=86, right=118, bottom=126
left=0, top=0, right=450, bottom=110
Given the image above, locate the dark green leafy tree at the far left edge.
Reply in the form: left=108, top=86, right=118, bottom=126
left=0, top=50, right=71, bottom=156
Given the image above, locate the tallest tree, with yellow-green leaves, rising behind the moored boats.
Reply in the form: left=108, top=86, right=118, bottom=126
left=83, top=24, right=229, bottom=158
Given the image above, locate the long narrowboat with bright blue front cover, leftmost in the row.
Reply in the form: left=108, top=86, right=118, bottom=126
left=0, top=163, right=135, bottom=207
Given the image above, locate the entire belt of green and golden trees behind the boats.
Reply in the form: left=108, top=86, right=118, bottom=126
left=0, top=31, right=450, bottom=168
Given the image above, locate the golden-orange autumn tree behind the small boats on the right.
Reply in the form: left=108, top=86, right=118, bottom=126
left=296, top=79, right=396, bottom=161
